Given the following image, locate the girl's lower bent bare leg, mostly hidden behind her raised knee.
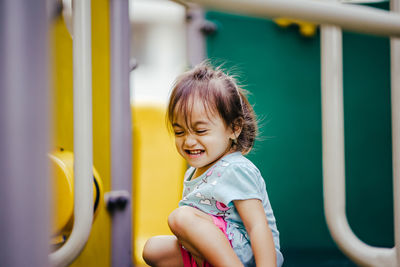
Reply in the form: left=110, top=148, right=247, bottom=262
left=143, top=235, right=183, bottom=267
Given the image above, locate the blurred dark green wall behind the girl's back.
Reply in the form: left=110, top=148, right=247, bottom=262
left=206, top=3, right=394, bottom=266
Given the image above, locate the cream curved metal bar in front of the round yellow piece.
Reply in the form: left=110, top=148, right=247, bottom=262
left=49, top=0, right=93, bottom=266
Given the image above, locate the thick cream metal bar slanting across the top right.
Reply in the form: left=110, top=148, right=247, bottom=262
left=186, top=0, right=400, bottom=37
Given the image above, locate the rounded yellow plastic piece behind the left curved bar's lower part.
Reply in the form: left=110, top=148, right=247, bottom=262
left=49, top=149, right=103, bottom=240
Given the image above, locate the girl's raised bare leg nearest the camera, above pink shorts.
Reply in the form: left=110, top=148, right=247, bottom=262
left=168, top=206, right=243, bottom=267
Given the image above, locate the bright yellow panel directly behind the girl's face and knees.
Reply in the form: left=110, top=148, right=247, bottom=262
left=132, top=106, right=186, bottom=264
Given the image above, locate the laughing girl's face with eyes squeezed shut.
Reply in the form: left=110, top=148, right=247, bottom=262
left=172, top=101, right=240, bottom=178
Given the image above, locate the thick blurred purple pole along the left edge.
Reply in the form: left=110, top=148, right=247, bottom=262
left=0, top=0, right=50, bottom=267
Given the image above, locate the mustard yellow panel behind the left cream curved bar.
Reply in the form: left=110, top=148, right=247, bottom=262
left=52, top=0, right=111, bottom=267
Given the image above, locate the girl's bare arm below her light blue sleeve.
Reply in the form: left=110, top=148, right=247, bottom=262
left=234, top=199, right=276, bottom=267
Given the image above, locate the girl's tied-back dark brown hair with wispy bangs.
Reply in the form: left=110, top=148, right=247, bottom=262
left=167, top=62, right=258, bottom=154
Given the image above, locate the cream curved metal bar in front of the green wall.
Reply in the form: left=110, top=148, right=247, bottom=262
left=321, top=25, right=399, bottom=266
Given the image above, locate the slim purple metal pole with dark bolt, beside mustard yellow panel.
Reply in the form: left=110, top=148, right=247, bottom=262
left=110, top=0, right=132, bottom=267
